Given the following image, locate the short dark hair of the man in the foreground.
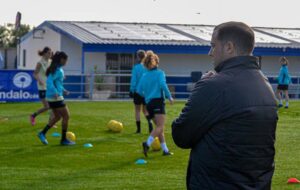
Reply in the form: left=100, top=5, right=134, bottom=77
left=214, top=22, right=255, bottom=54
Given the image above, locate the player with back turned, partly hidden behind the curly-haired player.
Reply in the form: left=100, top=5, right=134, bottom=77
left=129, top=50, right=153, bottom=133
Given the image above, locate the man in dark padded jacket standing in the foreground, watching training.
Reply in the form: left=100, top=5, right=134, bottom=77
left=172, top=22, right=277, bottom=190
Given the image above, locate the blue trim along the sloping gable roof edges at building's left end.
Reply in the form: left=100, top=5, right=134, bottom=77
left=21, top=21, right=83, bottom=44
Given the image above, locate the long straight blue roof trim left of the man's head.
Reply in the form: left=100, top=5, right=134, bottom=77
left=83, top=44, right=210, bottom=54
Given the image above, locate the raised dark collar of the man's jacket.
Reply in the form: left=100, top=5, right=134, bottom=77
left=215, top=56, right=259, bottom=73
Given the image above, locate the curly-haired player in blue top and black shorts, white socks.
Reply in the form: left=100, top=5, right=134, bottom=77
left=137, top=51, right=173, bottom=157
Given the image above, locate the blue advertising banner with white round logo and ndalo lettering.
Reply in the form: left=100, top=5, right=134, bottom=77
left=0, top=70, right=39, bottom=102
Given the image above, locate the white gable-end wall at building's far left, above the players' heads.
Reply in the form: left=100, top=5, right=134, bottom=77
left=18, top=27, right=61, bottom=70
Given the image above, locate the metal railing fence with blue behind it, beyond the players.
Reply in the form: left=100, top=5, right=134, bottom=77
left=65, top=72, right=300, bottom=100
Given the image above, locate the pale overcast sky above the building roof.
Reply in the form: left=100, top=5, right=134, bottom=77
left=0, top=0, right=300, bottom=28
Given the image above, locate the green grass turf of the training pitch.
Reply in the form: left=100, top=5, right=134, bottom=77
left=0, top=102, right=300, bottom=190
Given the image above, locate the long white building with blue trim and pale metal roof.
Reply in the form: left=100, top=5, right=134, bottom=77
left=18, top=21, right=300, bottom=98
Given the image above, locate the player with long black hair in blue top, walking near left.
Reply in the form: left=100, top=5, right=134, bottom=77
left=38, top=52, right=75, bottom=145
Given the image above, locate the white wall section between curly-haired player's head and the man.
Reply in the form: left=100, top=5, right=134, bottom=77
left=158, top=54, right=213, bottom=76
